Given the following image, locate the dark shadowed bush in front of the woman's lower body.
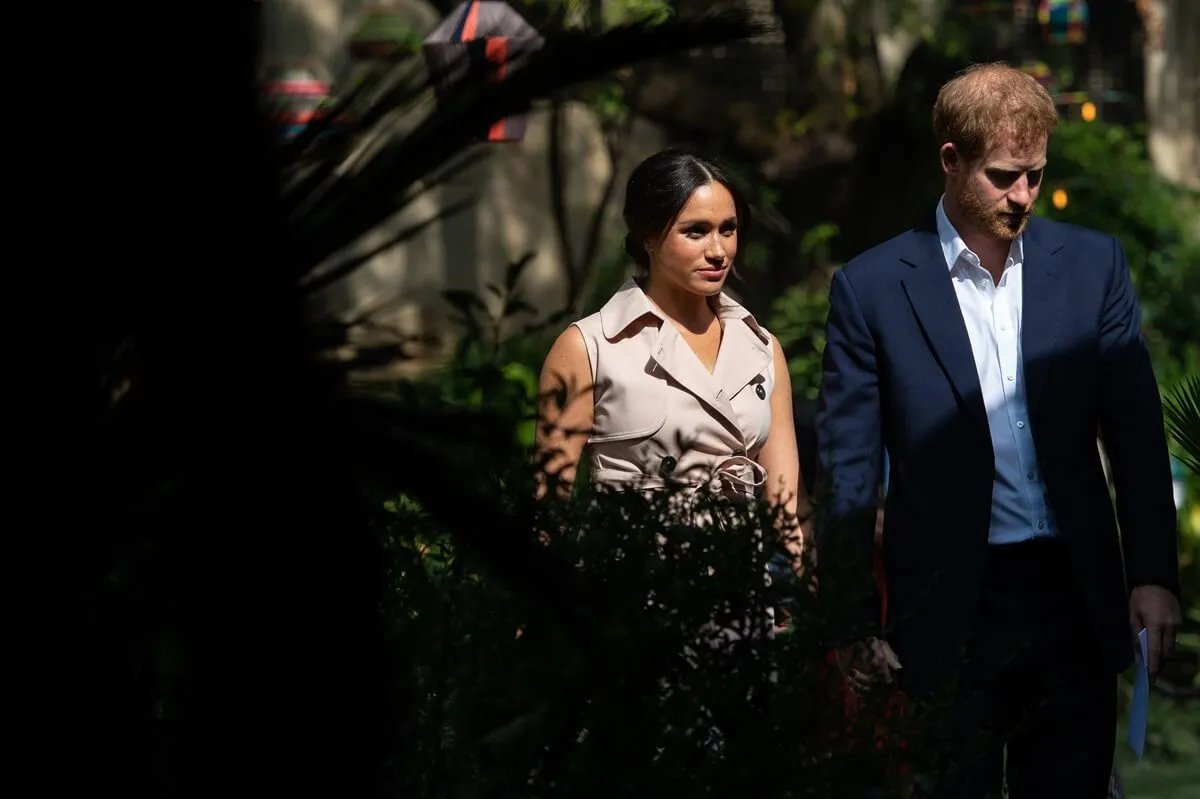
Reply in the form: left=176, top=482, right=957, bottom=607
left=382, top=471, right=919, bottom=799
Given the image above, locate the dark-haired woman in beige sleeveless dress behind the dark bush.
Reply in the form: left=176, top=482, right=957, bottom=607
left=538, top=149, right=809, bottom=554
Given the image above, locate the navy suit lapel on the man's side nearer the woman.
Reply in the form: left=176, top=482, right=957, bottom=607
left=901, top=229, right=989, bottom=435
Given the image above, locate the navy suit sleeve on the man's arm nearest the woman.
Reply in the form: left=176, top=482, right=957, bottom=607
left=816, top=271, right=883, bottom=644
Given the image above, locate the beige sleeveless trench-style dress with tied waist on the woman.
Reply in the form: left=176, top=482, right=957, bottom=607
left=575, top=280, right=775, bottom=498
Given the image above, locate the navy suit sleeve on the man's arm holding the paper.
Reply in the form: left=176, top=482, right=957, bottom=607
left=1099, top=239, right=1180, bottom=596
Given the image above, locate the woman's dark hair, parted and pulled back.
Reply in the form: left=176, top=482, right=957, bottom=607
left=623, top=148, right=750, bottom=269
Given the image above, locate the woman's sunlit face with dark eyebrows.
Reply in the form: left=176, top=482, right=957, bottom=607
left=650, top=181, right=738, bottom=296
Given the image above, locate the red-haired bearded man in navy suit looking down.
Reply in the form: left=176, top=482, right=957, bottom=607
left=816, top=64, right=1180, bottom=799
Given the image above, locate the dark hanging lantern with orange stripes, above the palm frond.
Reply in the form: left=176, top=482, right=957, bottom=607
left=422, top=0, right=542, bottom=142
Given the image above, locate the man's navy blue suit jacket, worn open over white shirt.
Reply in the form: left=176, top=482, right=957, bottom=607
left=816, top=218, right=1178, bottom=687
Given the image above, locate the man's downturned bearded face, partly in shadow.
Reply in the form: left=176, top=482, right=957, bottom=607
left=943, top=139, right=1048, bottom=241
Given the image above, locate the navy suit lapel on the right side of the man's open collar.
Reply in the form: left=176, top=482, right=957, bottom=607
left=1021, top=220, right=1067, bottom=415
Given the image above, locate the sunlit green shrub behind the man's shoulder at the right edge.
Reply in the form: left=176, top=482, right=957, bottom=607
left=1038, top=121, right=1200, bottom=386
